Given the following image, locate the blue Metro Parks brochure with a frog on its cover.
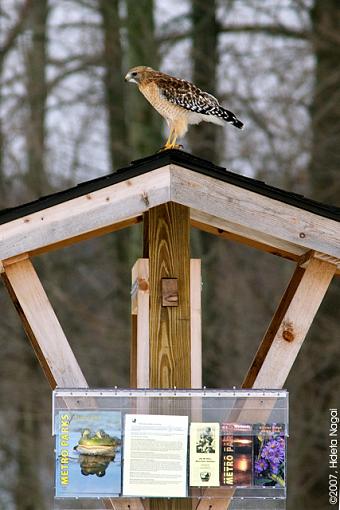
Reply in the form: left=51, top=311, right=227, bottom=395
left=56, top=410, right=121, bottom=498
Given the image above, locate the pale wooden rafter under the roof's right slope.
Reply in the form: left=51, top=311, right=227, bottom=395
left=171, top=165, right=340, bottom=258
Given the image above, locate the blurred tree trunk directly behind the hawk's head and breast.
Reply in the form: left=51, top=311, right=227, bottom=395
left=126, top=0, right=163, bottom=158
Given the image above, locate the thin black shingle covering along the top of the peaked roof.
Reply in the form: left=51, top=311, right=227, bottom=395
left=0, top=149, right=340, bottom=224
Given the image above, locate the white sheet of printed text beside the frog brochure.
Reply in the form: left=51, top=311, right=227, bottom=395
left=123, top=414, right=188, bottom=498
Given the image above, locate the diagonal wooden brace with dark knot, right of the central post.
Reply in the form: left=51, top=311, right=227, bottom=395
left=242, top=258, right=336, bottom=388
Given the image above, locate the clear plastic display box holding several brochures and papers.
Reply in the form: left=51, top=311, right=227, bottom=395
left=53, top=388, right=288, bottom=510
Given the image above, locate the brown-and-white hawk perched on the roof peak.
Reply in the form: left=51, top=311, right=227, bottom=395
left=125, top=66, right=243, bottom=149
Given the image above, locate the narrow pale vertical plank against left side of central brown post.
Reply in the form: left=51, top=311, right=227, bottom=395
left=130, top=259, right=150, bottom=388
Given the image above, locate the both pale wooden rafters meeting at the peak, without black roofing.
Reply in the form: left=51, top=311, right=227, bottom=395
left=0, top=164, right=340, bottom=270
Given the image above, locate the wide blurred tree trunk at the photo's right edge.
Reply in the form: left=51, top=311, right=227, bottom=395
left=310, top=0, right=340, bottom=205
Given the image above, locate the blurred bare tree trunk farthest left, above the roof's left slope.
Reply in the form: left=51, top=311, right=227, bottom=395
left=25, top=0, right=49, bottom=196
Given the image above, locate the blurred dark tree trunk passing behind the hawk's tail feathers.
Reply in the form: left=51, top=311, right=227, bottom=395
left=189, top=0, right=219, bottom=163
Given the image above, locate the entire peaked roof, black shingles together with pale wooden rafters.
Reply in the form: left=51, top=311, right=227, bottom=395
left=0, top=150, right=340, bottom=268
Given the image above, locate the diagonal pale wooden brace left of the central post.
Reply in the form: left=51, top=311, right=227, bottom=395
left=2, top=258, right=87, bottom=388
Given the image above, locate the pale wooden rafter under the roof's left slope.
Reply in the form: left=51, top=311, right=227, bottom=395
left=0, top=166, right=170, bottom=260
